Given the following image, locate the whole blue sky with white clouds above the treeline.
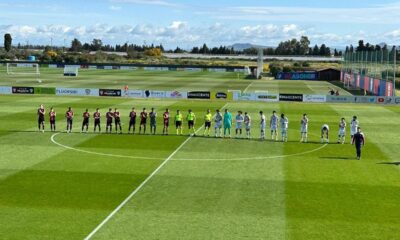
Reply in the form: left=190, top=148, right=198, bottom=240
left=0, top=0, right=400, bottom=48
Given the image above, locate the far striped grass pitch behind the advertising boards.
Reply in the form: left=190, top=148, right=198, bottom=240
left=0, top=66, right=349, bottom=95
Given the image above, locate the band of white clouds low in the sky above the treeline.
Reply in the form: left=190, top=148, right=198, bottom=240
left=0, top=21, right=400, bottom=48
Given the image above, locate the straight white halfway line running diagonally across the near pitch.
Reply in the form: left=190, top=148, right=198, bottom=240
left=84, top=104, right=228, bottom=240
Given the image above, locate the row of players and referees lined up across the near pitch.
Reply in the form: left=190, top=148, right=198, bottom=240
left=37, top=105, right=359, bottom=144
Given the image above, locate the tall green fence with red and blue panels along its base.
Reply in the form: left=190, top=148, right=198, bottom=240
left=340, top=47, right=400, bottom=96
